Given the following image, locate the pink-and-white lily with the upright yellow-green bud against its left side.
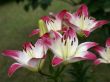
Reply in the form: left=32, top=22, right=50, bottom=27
left=29, top=10, right=66, bottom=37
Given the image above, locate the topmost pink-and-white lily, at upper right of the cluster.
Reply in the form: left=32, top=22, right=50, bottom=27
left=66, top=4, right=108, bottom=37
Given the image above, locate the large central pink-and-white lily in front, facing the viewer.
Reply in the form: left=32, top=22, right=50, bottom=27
left=45, top=28, right=97, bottom=66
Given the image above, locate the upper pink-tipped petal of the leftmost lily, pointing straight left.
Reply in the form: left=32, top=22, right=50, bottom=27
left=3, top=50, right=22, bottom=59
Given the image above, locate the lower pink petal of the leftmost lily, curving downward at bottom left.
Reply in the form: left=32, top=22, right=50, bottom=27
left=8, top=63, right=22, bottom=77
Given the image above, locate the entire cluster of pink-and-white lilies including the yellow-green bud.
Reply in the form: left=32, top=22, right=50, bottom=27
left=3, top=4, right=110, bottom=76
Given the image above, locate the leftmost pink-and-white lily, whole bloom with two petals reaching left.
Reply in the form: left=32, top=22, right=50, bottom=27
left=3, top=39, right=47, bottom=76
